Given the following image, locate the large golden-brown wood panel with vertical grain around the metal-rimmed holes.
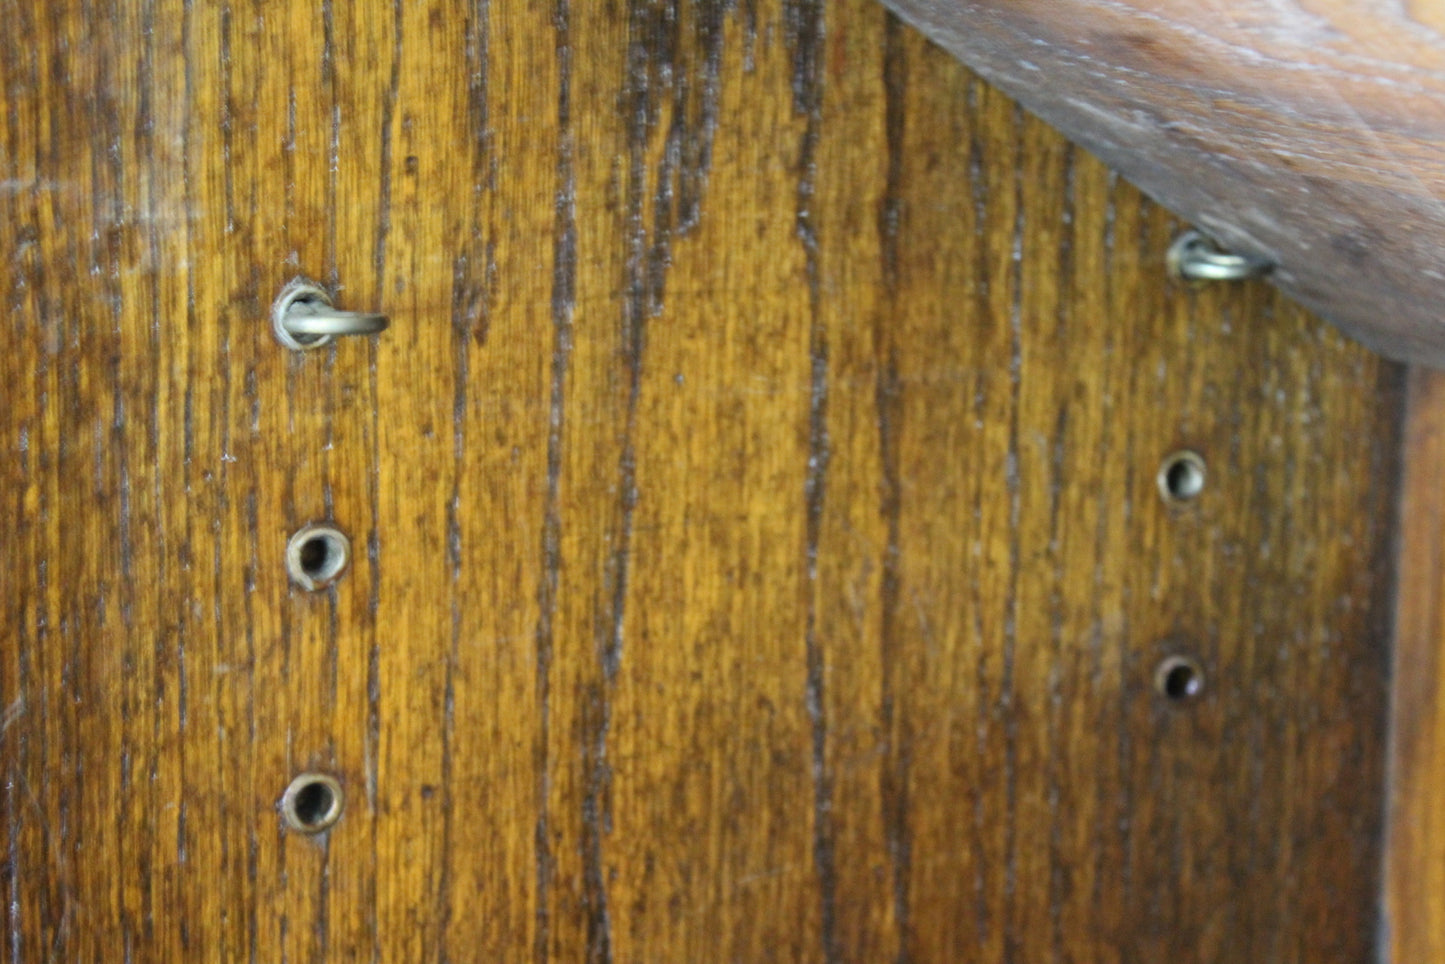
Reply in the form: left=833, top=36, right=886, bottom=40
left=0, top=0, right=1397, bottom=964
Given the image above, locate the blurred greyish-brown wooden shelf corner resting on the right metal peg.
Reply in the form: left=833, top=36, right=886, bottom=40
left=887, top=0, right=1445, bottom=367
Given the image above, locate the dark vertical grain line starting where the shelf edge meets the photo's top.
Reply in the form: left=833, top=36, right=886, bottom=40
left=873, top=12, right=913, bottom=964
